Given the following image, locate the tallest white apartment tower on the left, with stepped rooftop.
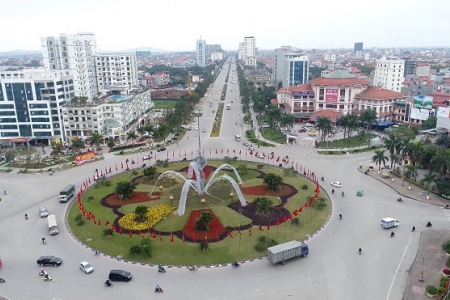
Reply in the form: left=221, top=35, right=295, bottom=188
left=41, top=33, right=98, bottom=99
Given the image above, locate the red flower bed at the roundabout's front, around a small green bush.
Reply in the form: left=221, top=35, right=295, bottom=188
left=183, top=209, right=225, bottom=242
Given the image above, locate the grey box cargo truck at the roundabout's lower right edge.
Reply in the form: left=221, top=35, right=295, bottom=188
left=267, top=241, right=309, bottom=265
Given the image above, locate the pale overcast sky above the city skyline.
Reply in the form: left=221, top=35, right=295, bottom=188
left=0, top=0, right=450, bottom=51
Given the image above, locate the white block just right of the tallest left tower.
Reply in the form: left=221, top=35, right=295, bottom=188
left=94, top=53, right=138, bottom=91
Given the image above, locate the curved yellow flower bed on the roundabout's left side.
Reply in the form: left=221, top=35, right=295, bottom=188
left=119, top=204, right=176, bottom=230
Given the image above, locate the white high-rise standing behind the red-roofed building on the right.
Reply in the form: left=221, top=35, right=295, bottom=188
left=373, top=56, right=405, bottom=92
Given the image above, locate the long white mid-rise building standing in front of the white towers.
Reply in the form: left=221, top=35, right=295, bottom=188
left=62, top=91, right=154, bottom=144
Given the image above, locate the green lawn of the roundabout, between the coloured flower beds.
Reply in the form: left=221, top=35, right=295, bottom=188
left=68, top=161, right=330, bottom=265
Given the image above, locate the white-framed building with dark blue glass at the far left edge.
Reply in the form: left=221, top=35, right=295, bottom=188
left=0, top=69, right=74, bottom=145
